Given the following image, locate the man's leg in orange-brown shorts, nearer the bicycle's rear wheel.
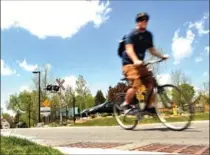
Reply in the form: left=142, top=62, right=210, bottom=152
left=122, top=65, right=141, bottom=106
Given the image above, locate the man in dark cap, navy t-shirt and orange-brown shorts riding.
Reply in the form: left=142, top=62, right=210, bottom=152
left=121, top=13, right=168, bottom=113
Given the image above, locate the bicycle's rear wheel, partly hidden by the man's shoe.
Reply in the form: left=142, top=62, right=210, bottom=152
left=113, top=93, right=138, bottom=130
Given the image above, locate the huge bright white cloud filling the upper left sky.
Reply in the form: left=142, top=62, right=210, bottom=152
left=1, top=0, right=111, bottom=39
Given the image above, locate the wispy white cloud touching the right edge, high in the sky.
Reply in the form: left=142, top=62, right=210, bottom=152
left=189, top=13, right=209, bottom=36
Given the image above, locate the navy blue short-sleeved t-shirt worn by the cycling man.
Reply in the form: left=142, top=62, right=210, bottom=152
left=122, top=29, right=153, bottom=65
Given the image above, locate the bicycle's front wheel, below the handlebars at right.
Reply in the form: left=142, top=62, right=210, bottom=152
left=156, top=84, right=193, bottom=131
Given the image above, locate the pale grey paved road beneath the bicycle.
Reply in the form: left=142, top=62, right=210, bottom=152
left=1, top=121, right=209, bottom=149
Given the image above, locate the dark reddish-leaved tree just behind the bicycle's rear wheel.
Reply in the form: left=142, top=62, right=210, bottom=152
left=107, top=82, right=129, bottom=101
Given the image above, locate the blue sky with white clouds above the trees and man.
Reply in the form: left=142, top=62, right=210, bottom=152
left=1, top=1, right=209, bottom=114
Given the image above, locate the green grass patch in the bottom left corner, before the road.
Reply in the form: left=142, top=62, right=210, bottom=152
left=1, top=136, right=62, bottom=155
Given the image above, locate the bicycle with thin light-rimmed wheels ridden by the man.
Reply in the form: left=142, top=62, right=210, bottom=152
left=113, top=59, right=194, bottom=131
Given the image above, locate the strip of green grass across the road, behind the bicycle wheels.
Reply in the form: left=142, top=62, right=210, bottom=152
left=73, top=113, right=209, bottom=126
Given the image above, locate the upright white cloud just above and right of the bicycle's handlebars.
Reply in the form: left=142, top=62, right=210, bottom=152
left=172, top=29, right=195, bottom=64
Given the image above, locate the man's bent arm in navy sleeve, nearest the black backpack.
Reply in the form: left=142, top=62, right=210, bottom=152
left=125, top=34, right=139, bottom=62
